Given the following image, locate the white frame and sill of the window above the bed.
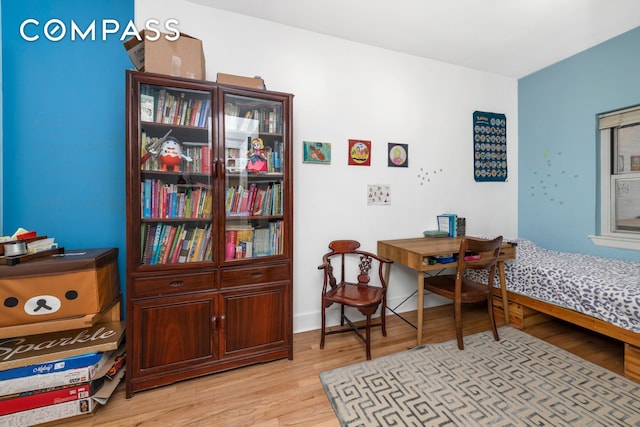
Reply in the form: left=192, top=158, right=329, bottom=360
left=589, top=106, right=640, bottom=250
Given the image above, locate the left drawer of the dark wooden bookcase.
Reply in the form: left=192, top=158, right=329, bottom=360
left=133, top=273, right=215, bottom=297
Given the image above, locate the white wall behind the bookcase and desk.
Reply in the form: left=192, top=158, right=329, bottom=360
left=135, top=0, right=518, bottom=332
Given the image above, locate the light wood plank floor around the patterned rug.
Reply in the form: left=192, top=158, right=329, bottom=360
left=64, top=305, right=623, bottom=427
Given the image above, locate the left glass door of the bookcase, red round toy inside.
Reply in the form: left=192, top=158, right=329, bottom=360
left=139, top=84, right=214, bottom=265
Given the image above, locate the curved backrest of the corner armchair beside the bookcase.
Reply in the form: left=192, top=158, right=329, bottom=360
left=318, top=240, right=393, bottom=291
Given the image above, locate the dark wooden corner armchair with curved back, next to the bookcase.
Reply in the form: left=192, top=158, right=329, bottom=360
left=318, top=240, right=393, bottom=360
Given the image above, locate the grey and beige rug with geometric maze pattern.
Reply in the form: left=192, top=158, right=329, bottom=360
left=320, top=326, right=640, bottom=427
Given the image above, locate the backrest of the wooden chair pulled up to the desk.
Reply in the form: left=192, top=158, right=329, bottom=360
left=456, top=236, right=502, bottom=288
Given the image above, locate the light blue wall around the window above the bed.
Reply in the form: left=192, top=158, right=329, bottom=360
left=518, top=27, right=640, bottom=260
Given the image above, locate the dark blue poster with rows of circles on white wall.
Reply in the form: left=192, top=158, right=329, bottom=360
left=473, top=111, right=507, bottom=182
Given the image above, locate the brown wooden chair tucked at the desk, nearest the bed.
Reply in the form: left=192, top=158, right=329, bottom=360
left=424, top=236, right=502, bottom=350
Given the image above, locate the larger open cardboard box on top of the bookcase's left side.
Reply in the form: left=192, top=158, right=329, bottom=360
left=124, top=30, right=206, bottom=80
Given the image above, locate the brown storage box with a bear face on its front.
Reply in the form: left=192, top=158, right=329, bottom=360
left=0, top=248, right=120, bottom=327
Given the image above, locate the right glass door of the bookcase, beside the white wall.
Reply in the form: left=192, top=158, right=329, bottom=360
left=224, top=93, right=288, bottom=261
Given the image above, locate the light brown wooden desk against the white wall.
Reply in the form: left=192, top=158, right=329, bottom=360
left=378, top=237, right=516, bottom=345
